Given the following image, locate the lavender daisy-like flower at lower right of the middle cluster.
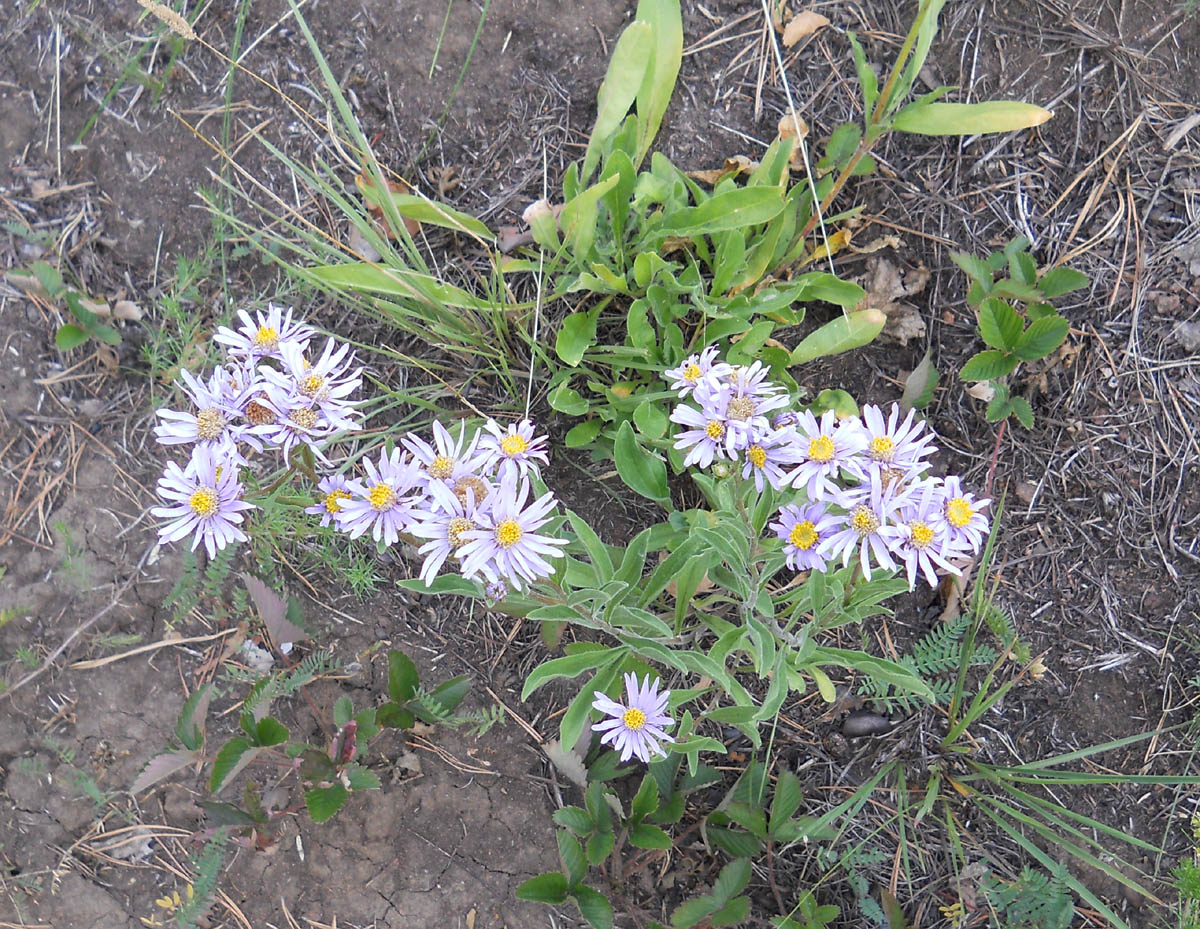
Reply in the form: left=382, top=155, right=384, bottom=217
left=457, top=472, right=566, bottom=591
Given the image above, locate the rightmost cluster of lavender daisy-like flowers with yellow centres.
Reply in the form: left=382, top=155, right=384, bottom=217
left=665, top=347, right=990, bottom=587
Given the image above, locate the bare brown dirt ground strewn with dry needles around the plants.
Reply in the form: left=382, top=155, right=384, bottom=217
left=0, top=0, right=1200, bottom=929
